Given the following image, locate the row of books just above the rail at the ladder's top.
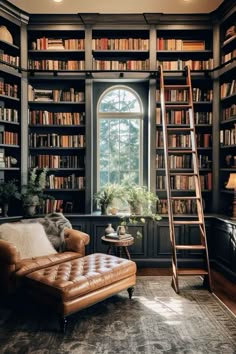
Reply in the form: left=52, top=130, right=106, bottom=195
left=157, top=58, right=214, bottom=71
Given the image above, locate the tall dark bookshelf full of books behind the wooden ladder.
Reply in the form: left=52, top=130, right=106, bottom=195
left=156, top=25, right=213, bottom=215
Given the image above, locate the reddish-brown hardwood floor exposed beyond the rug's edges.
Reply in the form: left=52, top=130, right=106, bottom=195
left=137, top=268, right=236, bottom=315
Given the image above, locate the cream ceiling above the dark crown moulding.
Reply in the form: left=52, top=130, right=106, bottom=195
left=9, top=0, right=223, bottom=14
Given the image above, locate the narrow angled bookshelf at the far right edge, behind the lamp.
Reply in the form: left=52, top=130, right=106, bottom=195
left=219, top=9, right=236, bottom=215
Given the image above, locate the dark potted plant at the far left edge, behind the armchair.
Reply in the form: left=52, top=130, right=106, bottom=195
left=0, top=179, right=20, bottom=216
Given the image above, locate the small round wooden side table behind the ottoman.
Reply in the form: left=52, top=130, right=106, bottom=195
left=102, top=236, right=134, bottom=259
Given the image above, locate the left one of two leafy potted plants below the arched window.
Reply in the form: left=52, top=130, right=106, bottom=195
left=94, top=183, right=124, bottom=215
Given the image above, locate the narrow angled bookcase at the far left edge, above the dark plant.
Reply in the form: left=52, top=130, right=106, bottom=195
left=0, top=8, right=22, bottom=215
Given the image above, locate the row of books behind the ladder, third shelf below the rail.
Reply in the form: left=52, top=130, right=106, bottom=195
left=156, top=130, right=212, bottom=148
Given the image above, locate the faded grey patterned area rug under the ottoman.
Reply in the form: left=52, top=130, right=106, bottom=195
left=0, top=276, right=236, bottom=354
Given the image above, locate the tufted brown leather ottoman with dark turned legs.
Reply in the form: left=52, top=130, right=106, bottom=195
left=25, top=253, right=136, bottom=331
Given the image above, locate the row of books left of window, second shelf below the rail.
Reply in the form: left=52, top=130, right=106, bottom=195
left=29, top=110, right=85, bottom=126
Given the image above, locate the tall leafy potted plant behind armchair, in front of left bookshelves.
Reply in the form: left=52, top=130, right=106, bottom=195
left=21, top=167, right=48, bottom=216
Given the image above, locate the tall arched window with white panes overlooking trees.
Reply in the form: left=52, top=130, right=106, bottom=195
left=97, top=85, right=143, bottom=189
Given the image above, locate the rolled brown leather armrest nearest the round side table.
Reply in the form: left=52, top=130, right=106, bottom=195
left=64, top=228, right=90, bottom=255
